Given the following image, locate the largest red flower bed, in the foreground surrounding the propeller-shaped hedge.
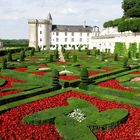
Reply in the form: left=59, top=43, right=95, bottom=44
left=0, top=91, right=140, bottom=140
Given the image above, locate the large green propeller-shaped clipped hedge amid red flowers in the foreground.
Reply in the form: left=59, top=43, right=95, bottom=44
left=23, top=98, right=128, bottom=140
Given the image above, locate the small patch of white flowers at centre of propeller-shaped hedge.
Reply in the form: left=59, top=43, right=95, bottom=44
left=68, top=108, right=86, bottom=122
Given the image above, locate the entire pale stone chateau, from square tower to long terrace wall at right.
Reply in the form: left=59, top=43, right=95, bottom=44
left=28, top=13, right=140, bottom=53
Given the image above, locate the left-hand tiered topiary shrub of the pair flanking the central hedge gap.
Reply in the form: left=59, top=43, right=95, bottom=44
left=52, top=69, right=60, bottom=88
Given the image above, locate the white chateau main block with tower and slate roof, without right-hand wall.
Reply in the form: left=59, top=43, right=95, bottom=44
left=28, top=14, right=99, bottom=49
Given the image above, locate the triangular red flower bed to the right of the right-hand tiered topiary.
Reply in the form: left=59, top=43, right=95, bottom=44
left=98, top=79, right=133, bottom=92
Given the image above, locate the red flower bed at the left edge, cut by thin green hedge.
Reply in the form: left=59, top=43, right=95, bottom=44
left=0, top=76, right=25, bottom=96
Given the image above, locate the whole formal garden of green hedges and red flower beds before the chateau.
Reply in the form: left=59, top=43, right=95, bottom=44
left=0, top=42, right=140, bottom=140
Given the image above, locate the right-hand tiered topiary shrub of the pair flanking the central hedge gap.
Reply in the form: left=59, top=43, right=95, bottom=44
left=79, top=68, right=89, bottom=90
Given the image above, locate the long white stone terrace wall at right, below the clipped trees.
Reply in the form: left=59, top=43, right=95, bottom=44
left=92, top=27, right=140, bottom=53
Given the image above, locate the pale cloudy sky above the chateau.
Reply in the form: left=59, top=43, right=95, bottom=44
left=0, top=0, right=123, bottom=39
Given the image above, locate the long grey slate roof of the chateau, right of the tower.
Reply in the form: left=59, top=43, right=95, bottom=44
left=52, top=25, right=93, bottom=32
